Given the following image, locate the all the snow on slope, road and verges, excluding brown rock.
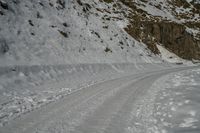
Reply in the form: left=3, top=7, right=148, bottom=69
left=0, top=0, right=200, bottom=133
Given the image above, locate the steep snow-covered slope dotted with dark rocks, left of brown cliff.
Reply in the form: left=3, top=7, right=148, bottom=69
left=0, top=0, right=162, bottom=66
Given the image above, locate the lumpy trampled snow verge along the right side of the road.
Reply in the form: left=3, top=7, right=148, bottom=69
left=154, top=69, right=200, bottom=133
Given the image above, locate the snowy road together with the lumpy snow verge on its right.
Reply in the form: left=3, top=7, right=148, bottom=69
left=0, top=67, right=200, bottom=133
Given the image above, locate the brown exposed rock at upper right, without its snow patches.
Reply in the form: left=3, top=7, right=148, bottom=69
left=121, top=0, right=200, bottom=60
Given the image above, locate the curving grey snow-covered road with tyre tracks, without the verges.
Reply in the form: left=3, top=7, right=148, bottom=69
left=0, top=67, right=198, bottom=133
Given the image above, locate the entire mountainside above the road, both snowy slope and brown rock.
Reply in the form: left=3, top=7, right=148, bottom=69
left=0, top=0, right=200, bottom=66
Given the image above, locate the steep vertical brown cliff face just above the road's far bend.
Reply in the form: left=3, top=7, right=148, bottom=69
left=148, top=22, right=200, bottom=60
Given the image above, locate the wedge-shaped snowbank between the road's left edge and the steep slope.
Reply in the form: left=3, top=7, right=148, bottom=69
left=0, top=64, right=171, bottom=127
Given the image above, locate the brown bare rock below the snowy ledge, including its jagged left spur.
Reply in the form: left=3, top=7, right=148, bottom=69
left=125, top=21, right=200, bottom=60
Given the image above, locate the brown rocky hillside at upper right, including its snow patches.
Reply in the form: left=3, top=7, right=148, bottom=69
left=119, top=0, right=200, bottom=60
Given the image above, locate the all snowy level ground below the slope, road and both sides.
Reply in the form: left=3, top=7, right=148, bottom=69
left=0, top=64, right=200, bottom=133
